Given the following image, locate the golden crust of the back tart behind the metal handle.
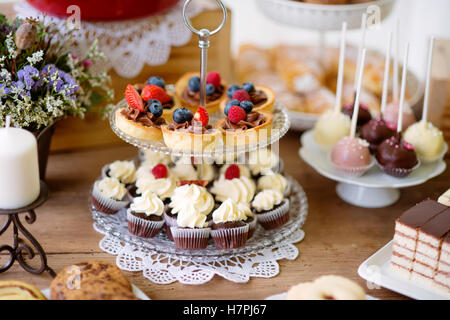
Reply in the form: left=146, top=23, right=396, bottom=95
left=174, top=72, right=227, bottom=114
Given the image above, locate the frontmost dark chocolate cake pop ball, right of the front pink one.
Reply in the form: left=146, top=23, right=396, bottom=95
left=377, top=133, right=419, bottom=178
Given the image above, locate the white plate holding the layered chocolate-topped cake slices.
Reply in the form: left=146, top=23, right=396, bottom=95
left=358, top=241, right=450, bottom=300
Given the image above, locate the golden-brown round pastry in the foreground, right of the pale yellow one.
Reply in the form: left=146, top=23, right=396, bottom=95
left=50, top=260, right=137, bottom=300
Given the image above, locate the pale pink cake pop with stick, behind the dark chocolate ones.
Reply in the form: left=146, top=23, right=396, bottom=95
left=383, top=19, right=416, bottom=130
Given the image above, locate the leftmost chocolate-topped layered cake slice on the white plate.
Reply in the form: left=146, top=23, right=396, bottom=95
left=391, top=200, right=448, bottom=278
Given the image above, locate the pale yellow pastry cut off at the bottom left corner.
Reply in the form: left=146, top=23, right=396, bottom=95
left=0, top=280, right=47, bottom=300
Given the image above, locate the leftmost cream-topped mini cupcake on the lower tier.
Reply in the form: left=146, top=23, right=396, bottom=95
left=92, top=177, right=130, bottom=214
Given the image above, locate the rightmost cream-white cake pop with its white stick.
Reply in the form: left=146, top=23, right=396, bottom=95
left=405, top=37, right=445, bottom=162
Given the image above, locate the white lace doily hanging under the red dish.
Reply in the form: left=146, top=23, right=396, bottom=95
left=14, top=1, right=206, bottom=78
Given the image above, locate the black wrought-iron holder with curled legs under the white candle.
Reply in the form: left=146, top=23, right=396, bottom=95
left=0, top=180, right=56, bottom=277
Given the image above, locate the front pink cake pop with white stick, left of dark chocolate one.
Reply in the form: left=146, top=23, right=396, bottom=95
left=330, top=49, right=372, bottom=176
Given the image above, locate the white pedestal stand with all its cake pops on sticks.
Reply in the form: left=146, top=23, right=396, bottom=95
left=299, top=23, right=448, bottom=208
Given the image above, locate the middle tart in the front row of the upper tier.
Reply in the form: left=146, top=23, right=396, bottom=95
left=161, top=107, right=222, bottom=151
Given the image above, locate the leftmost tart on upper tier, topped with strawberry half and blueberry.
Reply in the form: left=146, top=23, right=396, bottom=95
left=115, top=84, right=166, bottom=141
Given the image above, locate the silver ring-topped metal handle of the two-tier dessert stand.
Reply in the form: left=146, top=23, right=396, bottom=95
left=183, top=0, right=227, bottom=107
